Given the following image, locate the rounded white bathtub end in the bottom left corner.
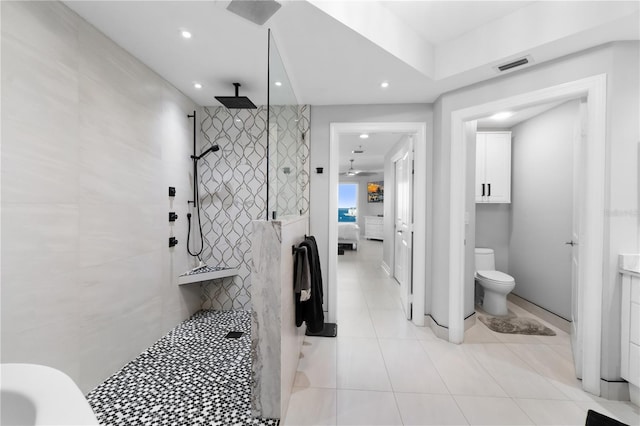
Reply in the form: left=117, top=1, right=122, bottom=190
left=0, top=364, right=98, bottom=426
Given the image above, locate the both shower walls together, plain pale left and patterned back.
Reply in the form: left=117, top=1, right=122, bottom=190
left=0, top=2, right=310, bottom=424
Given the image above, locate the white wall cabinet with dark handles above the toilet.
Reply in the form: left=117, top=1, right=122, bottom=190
left=476, top=132, right=511, bottom=203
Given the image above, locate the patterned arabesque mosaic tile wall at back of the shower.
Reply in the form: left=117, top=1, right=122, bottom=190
left=198, top=105, right=310, bottom=310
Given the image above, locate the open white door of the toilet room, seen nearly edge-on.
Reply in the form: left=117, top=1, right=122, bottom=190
left=566, top=102, right=587, bottom=378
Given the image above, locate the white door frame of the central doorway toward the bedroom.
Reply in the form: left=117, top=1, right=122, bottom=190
left=327, top=122, right=427, bottom=326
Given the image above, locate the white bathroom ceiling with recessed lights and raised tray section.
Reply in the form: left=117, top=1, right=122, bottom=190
left=65, top=0, right=640, bottom=105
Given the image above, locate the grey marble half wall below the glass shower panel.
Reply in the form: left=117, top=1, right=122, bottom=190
left=251, top=216, right=309, bottom=419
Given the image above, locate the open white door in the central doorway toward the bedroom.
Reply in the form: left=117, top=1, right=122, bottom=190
left=394, top=138, right=413, bottom=319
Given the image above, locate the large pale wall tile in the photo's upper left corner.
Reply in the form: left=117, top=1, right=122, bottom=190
left=2, top=13, right=78, bottom=203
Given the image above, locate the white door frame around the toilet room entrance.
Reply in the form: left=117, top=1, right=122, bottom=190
left=448, top=74, right=607, bottom=395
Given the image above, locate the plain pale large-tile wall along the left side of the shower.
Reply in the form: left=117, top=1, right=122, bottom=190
left=1, top=2, right=200, bottom=391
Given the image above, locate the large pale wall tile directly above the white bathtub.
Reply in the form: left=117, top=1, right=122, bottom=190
left=0, top=204, right=79, bottom=375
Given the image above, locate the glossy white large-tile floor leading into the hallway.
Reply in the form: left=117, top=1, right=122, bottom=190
left=283, top=241, right=640, bottom=426
